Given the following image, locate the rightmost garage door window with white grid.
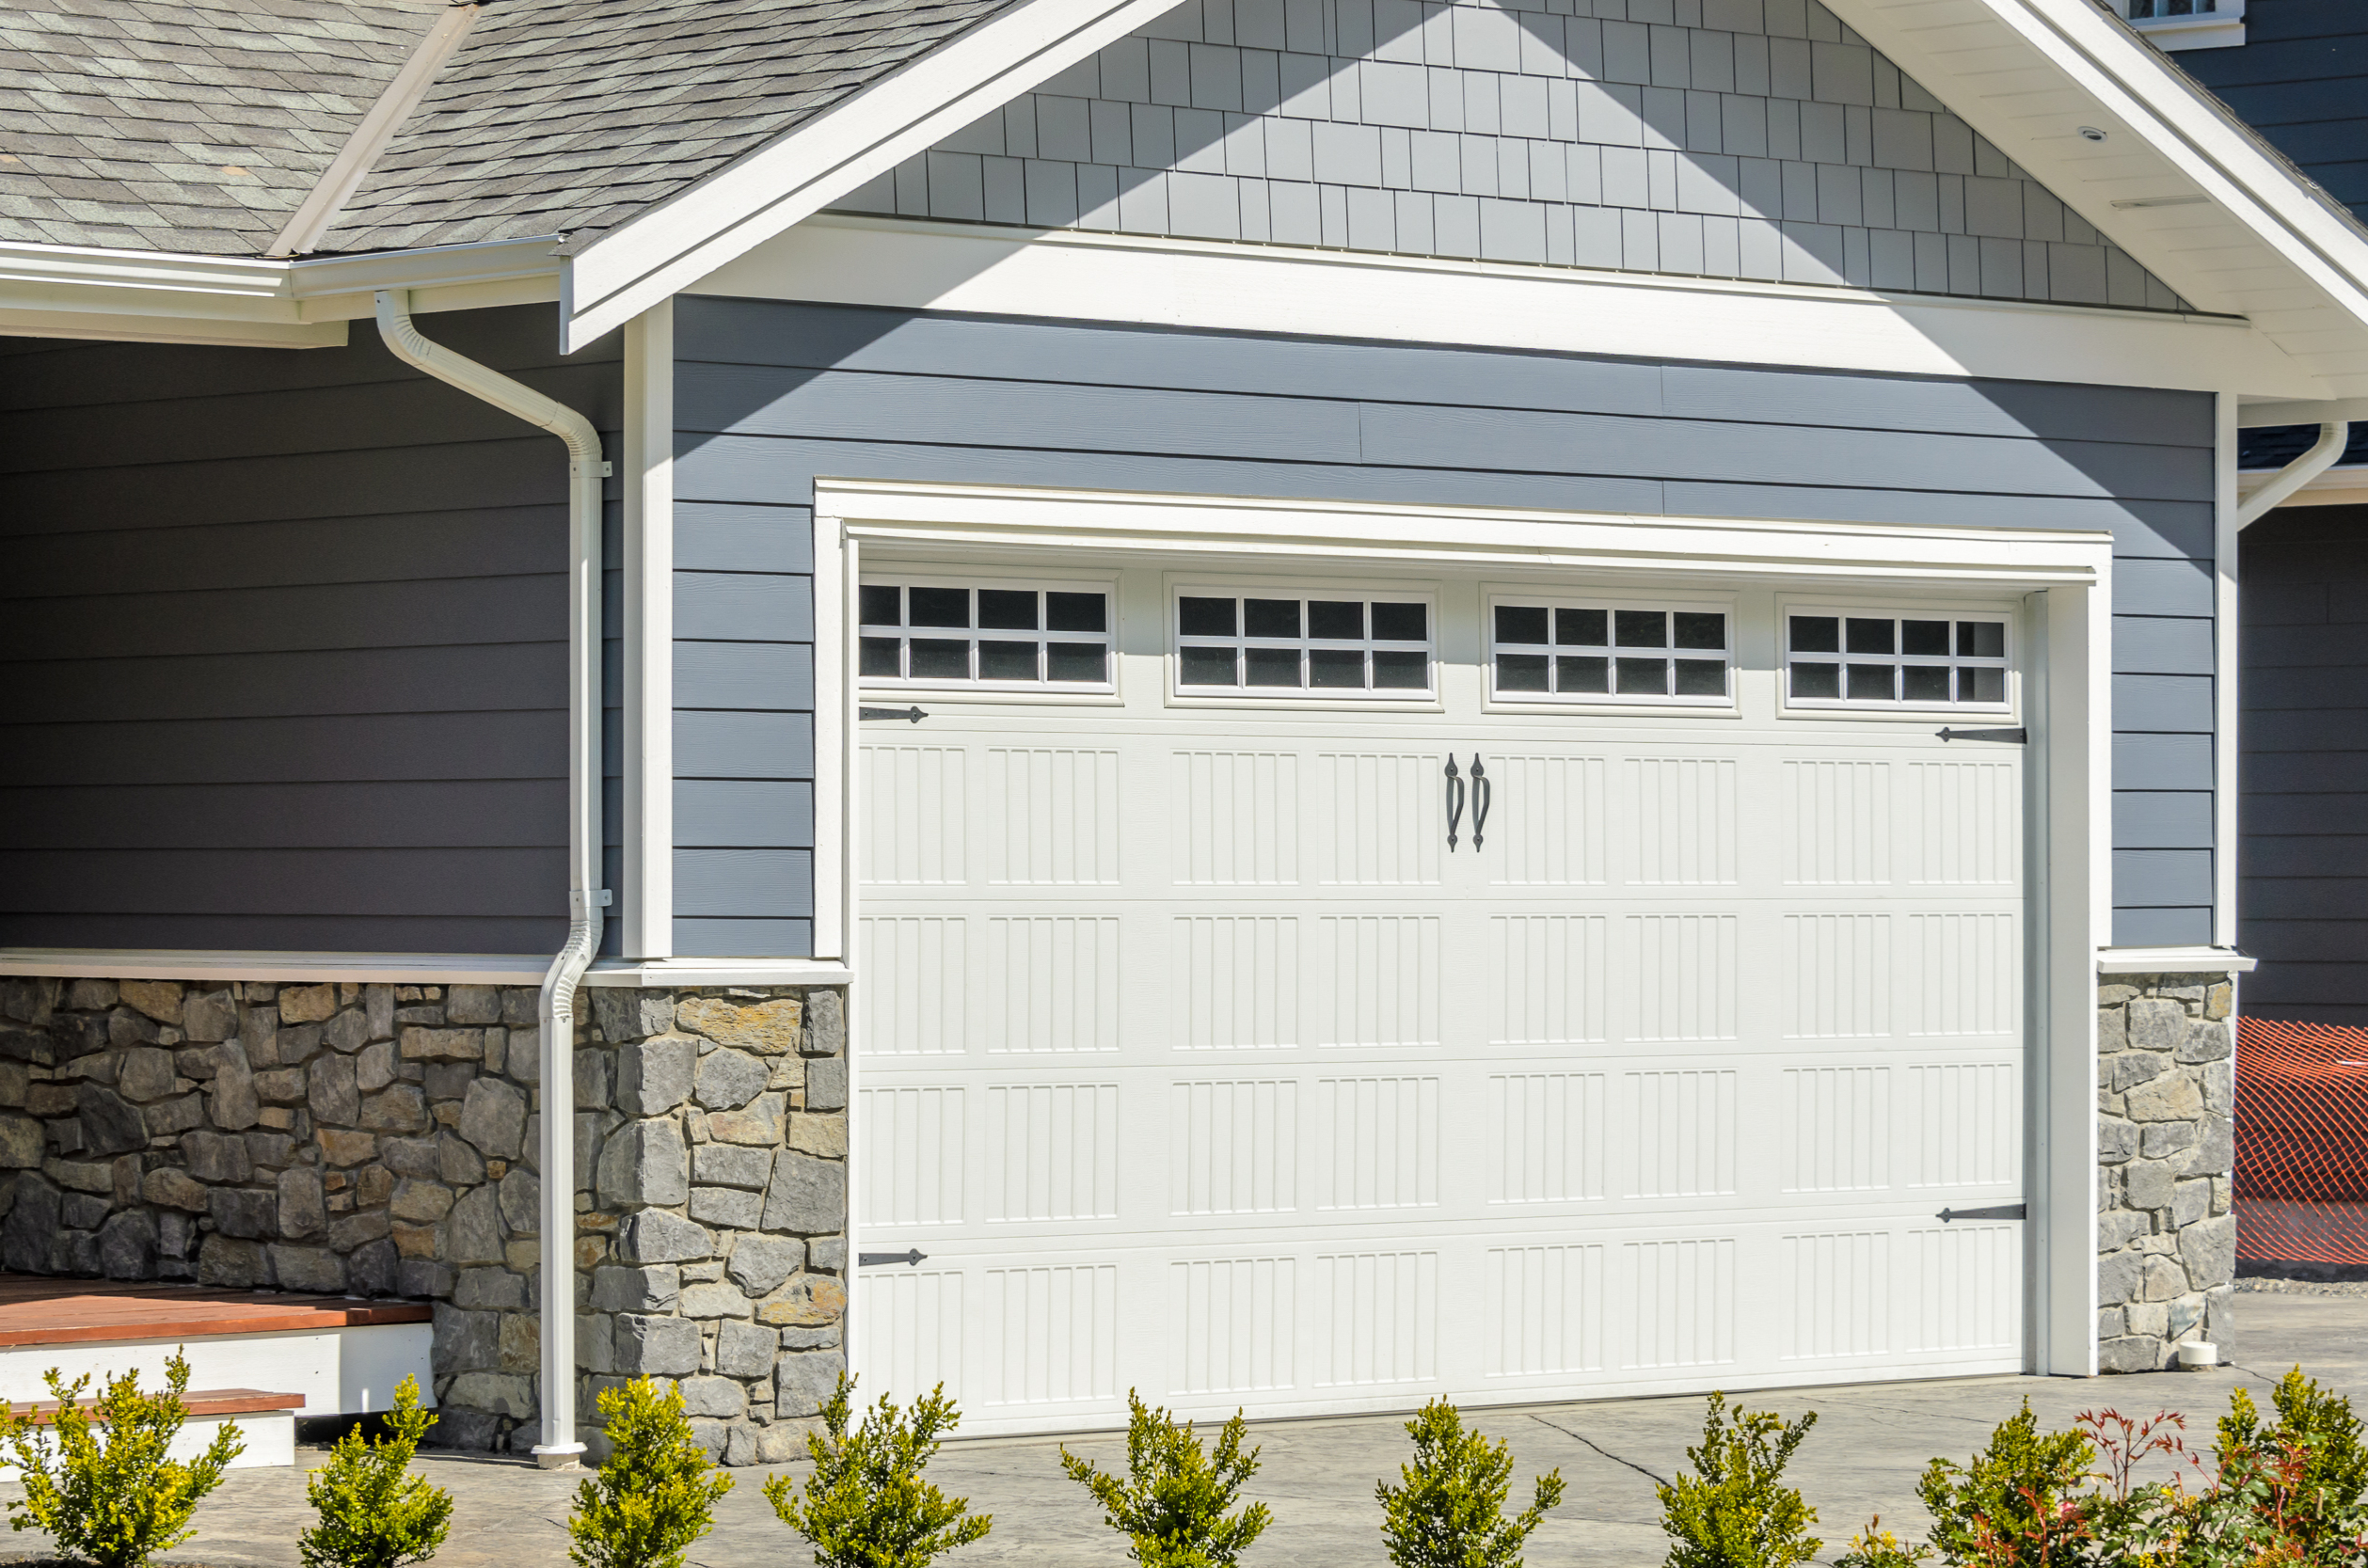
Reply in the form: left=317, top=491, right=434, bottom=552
left=1786, top=609, right=2008, bottom=710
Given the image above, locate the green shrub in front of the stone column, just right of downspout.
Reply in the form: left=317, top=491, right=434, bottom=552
left=568, top=1379, right=732, bottom=1568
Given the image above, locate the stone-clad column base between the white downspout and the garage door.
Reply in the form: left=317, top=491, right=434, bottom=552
left=576, top=988, right=848, bottom=1464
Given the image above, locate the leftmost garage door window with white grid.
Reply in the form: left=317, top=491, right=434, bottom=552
left=857, top=578, right=1110, bottom=691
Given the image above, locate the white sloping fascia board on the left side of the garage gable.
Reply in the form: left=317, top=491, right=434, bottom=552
left=562, top=0, right=1202, bottom=353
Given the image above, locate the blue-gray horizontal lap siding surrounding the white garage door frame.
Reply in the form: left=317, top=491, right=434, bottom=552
left=675, top=298, right=2217, bottom=952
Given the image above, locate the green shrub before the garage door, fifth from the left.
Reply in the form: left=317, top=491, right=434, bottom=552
left=1061, top=1388, right=1274, bottom=1568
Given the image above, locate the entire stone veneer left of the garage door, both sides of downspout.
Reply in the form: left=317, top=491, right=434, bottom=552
left=0, top=978, right=846, bottom=1464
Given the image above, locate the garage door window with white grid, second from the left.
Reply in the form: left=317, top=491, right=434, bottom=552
left=1174, top=587, right=1433, bottom=696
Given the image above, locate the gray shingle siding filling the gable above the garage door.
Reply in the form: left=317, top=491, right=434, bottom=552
left=841, top=0, right=2181, bottom=310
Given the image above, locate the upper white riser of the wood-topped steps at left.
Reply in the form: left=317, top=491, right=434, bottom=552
left=0, top=1324, right=436, bottom=1420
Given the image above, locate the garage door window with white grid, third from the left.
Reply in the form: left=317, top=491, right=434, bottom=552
left=1489, top=597, right=1728, bottom=705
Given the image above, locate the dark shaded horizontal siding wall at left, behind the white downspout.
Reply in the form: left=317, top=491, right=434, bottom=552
left=0, top=306, right=623, bottom=952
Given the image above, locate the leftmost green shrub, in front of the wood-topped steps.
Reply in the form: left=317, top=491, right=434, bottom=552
left=0, top=1350, right=246, bottom=1568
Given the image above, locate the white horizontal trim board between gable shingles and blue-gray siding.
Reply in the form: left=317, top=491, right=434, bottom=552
left=691, top=214, right=2318, bottom=396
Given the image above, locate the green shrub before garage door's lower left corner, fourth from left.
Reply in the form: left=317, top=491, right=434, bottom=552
left=765, top=1374, right=994, bottom=1568
